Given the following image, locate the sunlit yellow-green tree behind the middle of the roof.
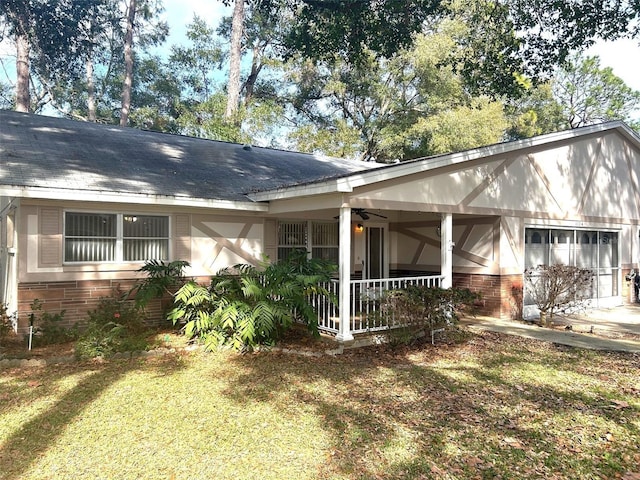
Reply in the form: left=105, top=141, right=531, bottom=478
left=287, top=20, right=507, bottom=162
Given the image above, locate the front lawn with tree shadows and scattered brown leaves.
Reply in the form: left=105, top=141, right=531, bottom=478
left=0, top=333, right=640, bottom=480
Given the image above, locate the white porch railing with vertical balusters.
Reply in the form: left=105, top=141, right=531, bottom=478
left=311, top=275, right=444, bottom=334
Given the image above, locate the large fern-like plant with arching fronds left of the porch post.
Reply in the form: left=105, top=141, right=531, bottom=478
left=169, top=251, right=337, bottom=351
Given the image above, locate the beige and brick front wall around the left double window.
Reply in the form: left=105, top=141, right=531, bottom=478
left=10, top=200, right=265, bottom=332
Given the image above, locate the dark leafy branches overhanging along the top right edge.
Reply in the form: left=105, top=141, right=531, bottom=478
left=282, top=0, right=640, bottom=88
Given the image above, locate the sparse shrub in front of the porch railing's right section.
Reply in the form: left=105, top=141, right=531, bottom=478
left=380, top=285, right=480, bottom=344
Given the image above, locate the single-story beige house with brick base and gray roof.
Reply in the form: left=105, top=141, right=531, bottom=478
left=0, top=111, right=640, bottom=341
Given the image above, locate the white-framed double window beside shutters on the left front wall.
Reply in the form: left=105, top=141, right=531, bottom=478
left=64, top=212, right=169, bottom=262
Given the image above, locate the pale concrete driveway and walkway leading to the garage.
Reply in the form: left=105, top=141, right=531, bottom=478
left=461, top=305, right=640, bottom=353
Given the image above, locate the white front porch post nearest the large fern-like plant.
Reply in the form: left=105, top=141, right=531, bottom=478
left=336, top=206, right=353, bottom=342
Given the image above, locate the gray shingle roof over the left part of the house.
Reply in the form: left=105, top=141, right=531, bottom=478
left=0, top=110, right=379, bottom=201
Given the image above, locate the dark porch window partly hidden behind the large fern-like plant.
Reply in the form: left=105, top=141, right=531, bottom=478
left=278, top=221, right=339, bottom=264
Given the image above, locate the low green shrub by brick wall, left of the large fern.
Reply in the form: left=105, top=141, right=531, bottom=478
left=76, top=297, right=148, bottom=358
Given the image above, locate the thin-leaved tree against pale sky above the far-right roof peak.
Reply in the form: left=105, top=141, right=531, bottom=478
left=552, top=54, right=640, bottom=128
